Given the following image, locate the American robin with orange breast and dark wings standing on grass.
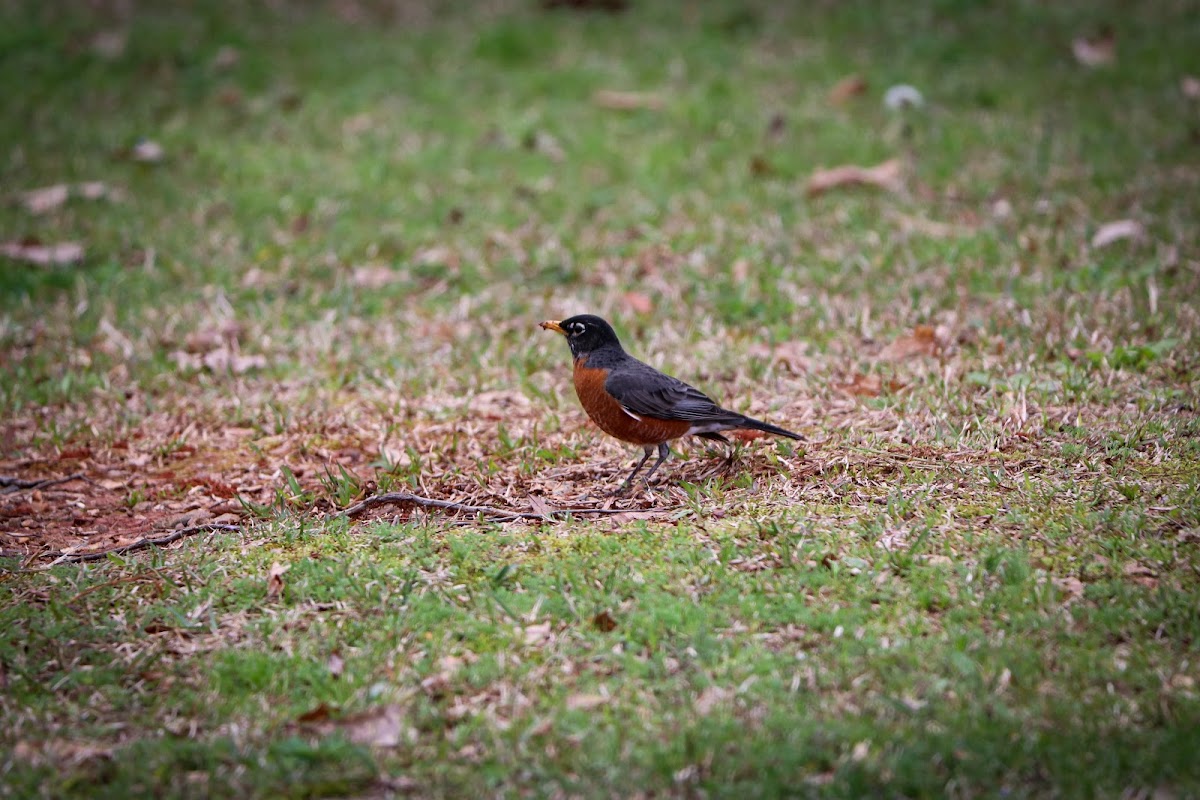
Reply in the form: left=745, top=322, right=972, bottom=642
left=541, top=314, right=804, bottom=492
